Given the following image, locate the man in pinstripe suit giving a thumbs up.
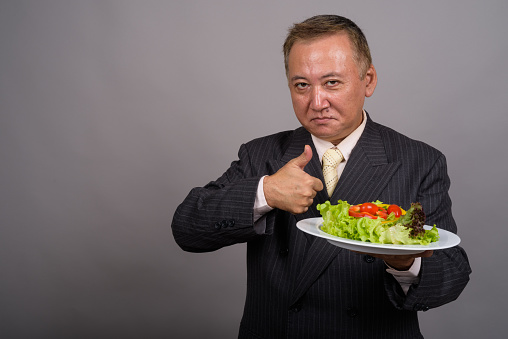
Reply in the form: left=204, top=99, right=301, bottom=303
left=172, top=15, right=471, bottom=338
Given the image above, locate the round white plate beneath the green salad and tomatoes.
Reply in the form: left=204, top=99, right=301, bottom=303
left=296, top=218, right=460, bottom=255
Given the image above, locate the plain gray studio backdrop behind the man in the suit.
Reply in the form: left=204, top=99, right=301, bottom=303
left=0, top=0, right=508, bottom=338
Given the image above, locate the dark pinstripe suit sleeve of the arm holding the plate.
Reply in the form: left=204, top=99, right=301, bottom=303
left=385, top=154, right=471, bottom=311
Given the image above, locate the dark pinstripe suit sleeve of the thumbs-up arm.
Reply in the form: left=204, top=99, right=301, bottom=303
left=171, top=145, right=261, bottom=252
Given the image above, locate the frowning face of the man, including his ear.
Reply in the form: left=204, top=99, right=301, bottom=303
left=288, top=34, right=377, bottom=144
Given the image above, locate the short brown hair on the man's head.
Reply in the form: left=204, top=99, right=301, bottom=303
left=282, top=15, right=372, bottom=79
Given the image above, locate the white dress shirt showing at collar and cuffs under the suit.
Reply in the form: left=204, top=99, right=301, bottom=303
left=254, top=111, right=421, bottom=294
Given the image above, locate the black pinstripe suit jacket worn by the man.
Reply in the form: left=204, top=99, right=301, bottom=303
left=172, top=117, right=471, bottom=338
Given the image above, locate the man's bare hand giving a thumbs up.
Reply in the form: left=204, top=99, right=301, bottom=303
left=263, top=145, right=323, bottom=214
